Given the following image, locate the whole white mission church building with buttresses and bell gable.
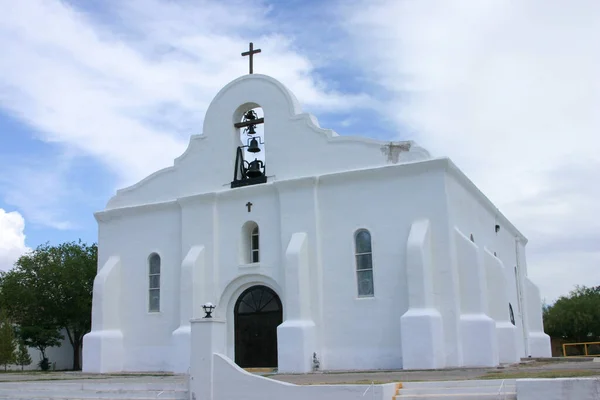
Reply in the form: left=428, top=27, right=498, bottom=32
left=83, top=66, right=550, bottom=372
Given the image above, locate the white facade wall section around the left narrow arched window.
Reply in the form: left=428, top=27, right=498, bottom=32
left=84, top=203, right=182, bottom=372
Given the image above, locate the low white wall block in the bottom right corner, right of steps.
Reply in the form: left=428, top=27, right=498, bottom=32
left=517, top=378, right=600, bottom=400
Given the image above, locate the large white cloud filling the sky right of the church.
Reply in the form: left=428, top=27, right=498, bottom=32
left=343, top=0, right=600, bottom=300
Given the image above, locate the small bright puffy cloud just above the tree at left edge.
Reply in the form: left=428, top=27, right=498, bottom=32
left=0, top=208, right=30, bottom=271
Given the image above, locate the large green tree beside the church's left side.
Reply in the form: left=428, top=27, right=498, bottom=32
left=0, top=241, right=98, bottom=370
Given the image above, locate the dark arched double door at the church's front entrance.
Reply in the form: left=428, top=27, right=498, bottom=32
left=233, top=285, right=283, bottom=368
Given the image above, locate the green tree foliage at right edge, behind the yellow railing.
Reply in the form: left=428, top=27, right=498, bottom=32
left=544, top=286, right=600, bottom=342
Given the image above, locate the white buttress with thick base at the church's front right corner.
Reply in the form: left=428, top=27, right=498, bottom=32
left=400, top=220, right=445, bottom=369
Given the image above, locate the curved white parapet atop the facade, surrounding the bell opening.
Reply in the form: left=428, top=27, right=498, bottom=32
left=106, top=74, right=430, bottom=210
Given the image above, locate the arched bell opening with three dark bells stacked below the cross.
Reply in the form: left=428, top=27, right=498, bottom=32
left=231, top=105, right=267, bottom=188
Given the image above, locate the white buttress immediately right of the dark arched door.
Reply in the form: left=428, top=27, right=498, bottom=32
left=277, top=232, right=316, bottom=373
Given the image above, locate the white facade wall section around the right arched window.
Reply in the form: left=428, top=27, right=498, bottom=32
left=319, top=164, right=445, bottom=369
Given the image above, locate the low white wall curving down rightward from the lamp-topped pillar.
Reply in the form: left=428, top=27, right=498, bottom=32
left=212, top=354, right=396, bottom=400
